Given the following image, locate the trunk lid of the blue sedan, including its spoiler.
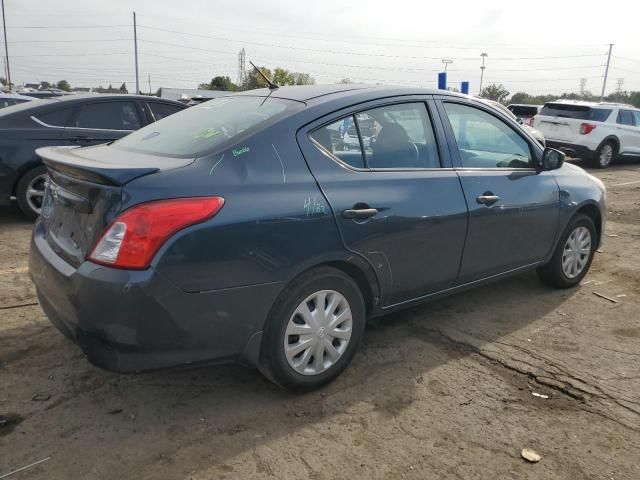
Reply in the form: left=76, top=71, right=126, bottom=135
left=36, top=145, right=193, bottom=267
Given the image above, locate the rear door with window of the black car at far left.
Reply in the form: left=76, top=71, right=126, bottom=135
left=64, top=100, right=143, bottom=146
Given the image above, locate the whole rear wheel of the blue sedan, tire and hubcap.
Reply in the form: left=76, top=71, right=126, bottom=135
left=260, top=267, right=365, bottom=391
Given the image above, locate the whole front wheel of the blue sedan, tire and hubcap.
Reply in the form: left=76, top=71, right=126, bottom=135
left=538, top=214, right=598, bottom=288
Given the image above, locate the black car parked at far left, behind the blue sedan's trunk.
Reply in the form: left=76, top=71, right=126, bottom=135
left=0, top=94, right=187, bottom=218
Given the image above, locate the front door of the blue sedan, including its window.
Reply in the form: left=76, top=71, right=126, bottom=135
left=440, top=100, right=560, bottom=283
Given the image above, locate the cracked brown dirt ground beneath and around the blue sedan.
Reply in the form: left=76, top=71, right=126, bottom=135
left=0, top=162, right=640, bottom=480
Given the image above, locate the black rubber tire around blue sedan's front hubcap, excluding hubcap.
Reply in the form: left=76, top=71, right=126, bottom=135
left=537, top=214, right=598, bottom=288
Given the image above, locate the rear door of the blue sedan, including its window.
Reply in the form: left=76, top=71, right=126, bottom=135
left=298, top=98, right=467, bottom=306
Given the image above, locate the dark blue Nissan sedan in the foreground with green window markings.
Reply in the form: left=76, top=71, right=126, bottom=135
left=29, top=85, right=605, bottom=391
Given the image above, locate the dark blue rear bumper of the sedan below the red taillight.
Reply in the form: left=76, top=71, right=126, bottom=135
left=29, top=222, right=280, bottom=372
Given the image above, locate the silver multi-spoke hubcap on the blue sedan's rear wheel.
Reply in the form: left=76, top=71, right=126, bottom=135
left=284, top=290, right=353, bottom=375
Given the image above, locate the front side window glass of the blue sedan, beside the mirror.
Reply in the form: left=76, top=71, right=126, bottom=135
left=444, top=103, right=532, bottom=168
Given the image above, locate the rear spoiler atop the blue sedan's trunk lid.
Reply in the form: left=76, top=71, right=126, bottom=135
left=36, top=147, right=160, bottom=187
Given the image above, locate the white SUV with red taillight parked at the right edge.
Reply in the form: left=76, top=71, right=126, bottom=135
left=533, top=100, right=640, bottom=168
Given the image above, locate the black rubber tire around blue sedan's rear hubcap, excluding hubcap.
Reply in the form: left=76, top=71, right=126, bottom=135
left=259, top=267, right=366, bottom=392
